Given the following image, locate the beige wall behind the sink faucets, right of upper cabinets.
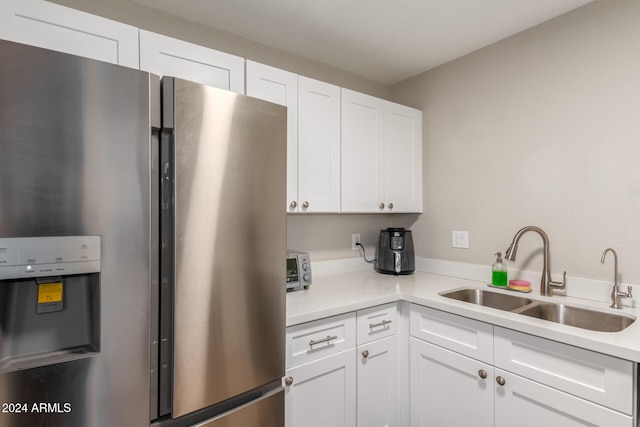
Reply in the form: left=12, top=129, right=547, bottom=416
left=392, top=0, right=640, bottom=283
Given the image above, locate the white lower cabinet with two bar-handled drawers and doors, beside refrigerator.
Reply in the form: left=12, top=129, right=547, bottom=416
left=284, top=303, right=399, bottom=427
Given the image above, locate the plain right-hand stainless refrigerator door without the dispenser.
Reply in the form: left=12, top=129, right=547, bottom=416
left=163, top=79, right=287, bottom=418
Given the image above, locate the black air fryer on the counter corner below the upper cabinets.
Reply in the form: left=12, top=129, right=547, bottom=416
left=376, top=228, right=416, bottom=274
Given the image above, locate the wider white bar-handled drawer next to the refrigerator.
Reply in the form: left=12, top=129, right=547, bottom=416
left=287, top=313, right=356, bottom=368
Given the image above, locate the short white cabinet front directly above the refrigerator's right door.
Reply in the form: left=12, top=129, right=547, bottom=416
left=140, top=30, right=244, bottom=94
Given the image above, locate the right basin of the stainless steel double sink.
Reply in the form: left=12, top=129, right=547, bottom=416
left=518, top=302, right=636, bottom=332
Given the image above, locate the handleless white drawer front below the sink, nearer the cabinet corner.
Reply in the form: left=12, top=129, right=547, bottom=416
left=409, top=305, right=493, bottom=364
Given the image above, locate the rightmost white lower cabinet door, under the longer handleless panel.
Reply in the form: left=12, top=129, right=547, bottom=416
left=492, top=368, right=633, bottom=427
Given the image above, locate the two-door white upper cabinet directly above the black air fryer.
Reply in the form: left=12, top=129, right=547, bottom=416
left=342, top=88, right=422, bottom=213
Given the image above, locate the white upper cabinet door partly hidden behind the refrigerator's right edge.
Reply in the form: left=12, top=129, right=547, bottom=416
left=247, top=60, right=299, bottom=212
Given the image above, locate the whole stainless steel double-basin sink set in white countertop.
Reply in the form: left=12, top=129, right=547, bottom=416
left=440, top=288, right=636, bottom=332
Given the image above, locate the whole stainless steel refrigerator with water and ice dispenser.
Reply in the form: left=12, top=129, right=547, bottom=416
left=0, top=41, right=286, bottom=427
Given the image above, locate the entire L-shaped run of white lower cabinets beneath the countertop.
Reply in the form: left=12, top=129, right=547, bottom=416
left=284, top=303, right=638, bottom=427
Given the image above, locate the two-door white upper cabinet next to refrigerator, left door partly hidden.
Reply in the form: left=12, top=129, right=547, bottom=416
left=247, top=67, right=340, bottom=213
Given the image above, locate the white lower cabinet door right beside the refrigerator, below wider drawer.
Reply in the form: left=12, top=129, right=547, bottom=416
left=285, top=349, right=356, bottom=427
